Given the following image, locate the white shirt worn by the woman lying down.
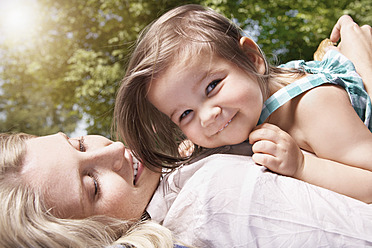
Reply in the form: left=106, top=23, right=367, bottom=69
left=147, top=146, right=372, bottom=248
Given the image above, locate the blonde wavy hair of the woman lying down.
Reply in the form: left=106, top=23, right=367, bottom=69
left=0, top=134, right=173, bottom=248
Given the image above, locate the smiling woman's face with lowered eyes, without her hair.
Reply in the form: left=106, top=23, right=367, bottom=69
left=22, top=133, right=160, bottom=220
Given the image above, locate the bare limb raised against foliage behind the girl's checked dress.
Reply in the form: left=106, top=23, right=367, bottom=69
left=330, top=15, right=372, bottom=93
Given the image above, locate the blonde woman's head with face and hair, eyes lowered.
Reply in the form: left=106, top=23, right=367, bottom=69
left=0, top=133, right=173, bottom=248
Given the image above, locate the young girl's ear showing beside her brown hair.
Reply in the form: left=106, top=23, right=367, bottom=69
left=239, top=36, right=266, bottom=74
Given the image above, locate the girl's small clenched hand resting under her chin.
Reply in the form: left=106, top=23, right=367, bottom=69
left=249, top=123, right=304, bottom=178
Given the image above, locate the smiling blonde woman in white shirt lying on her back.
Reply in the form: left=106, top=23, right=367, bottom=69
left=0, top=14, right=372, bottom=247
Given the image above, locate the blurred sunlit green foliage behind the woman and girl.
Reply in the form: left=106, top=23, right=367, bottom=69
left=0, top=0, right=372, bottom=136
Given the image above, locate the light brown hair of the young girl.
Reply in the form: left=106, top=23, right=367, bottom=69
left=114, top=5, right=302, bottom=168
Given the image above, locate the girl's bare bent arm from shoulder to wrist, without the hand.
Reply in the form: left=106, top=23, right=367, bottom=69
left=292, top=85, right=372, bottom=203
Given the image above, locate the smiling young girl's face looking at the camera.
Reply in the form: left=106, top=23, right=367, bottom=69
left=148, top=45, right=264, bottom=148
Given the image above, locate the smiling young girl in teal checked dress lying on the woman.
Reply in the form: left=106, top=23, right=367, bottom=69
left=115, top=5, right=372, bottom=203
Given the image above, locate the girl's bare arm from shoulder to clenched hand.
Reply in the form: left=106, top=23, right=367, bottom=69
left=249, top=85, right=372, bottom=203
